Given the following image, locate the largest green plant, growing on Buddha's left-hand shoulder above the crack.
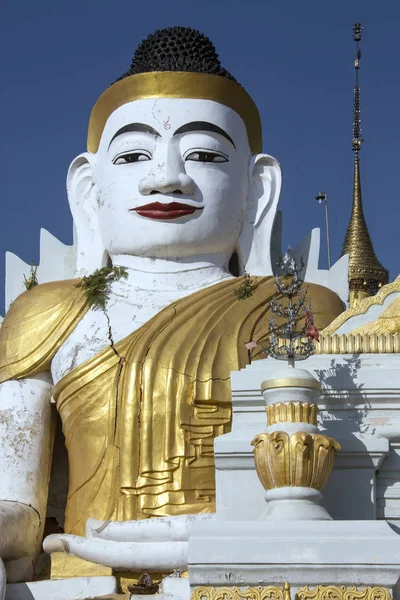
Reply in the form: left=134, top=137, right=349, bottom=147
left=76, top=266, right=128, bottom=312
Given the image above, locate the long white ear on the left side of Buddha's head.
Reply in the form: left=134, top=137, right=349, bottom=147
left=67, top=152, right=108, bottom=277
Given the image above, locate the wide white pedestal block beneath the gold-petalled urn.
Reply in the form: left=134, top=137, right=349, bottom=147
left=189, top=520, right=400, bottom=600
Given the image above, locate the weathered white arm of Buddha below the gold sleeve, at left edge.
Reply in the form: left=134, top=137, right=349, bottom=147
left=0, top=375, right=53, bottom=576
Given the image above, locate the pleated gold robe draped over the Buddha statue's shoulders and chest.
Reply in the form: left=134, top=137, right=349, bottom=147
left=0, top=277, right=343, bottom=535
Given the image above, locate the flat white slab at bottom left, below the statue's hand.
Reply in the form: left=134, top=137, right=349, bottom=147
left=5, top=577, right=117, bottom=600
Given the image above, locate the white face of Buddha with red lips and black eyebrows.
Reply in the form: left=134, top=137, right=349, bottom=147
left=95, top=98, right=251, bottom=261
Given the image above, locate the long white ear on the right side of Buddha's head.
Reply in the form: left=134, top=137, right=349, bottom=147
left=236, top=154, right=282, bottom=276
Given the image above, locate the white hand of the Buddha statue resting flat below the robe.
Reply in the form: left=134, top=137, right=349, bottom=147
left=43, top=514, right=215, bottom=571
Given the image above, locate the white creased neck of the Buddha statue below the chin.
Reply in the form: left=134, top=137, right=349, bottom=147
left=112, top=255, right=232, bottom=296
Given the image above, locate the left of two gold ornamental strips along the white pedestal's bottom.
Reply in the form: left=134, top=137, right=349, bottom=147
left=191, top=583, right=290, bottom=600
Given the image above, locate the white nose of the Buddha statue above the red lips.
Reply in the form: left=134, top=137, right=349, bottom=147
left=139, top=157, right=195, bottom=196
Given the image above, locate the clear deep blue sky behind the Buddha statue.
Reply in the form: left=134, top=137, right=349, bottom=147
left=0, top=0, right=400, bottom=312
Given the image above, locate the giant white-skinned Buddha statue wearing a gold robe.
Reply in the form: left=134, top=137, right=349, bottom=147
left=0, top=27, right=343, bottom=584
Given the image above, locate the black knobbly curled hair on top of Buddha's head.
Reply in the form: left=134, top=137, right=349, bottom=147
left=117, top=27, right=236, bottom=81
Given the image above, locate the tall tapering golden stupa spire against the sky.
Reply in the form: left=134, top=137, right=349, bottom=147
left=341, top=21, right=389, bottom=307
